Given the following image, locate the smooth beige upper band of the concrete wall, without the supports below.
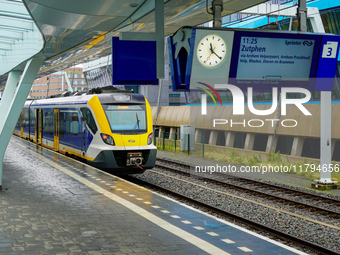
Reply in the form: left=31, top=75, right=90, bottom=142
left=152, top=104, right=340, bottom=139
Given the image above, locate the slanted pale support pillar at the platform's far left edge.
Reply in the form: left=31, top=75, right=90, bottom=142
left=0, top=54, right=45, bottom=189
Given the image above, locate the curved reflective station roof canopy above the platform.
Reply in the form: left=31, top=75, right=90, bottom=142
left=0, top=0, right=266, bottom=86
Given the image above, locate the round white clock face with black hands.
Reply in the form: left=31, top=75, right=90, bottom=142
left=196, top=34, right=227, bottom=68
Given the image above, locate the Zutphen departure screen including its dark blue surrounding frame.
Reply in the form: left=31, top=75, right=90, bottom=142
left=229, top=32, right=320, bottom=89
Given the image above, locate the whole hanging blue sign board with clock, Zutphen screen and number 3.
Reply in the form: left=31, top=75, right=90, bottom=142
left=169, top=28, right=340, bottom=91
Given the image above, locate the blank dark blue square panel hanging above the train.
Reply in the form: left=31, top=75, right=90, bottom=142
left=112, top=37, right=158, bottom=85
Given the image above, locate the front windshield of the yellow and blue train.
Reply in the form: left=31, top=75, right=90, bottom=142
left=103, top=105, right=147, bottom=133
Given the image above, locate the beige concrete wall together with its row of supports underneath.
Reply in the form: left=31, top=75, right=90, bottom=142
left=152, top=104, right=340, bottom=161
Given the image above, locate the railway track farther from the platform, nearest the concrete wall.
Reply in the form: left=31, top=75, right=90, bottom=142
left=156, top=158, right=340, bottom=219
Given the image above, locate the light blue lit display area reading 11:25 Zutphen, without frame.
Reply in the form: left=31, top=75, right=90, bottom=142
left=234, top=36, right=315, bottom=86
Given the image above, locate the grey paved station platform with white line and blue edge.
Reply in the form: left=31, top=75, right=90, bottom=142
left=0, top=136, right=305, bottom=255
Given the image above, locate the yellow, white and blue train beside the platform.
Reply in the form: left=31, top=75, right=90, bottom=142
left=13, top=92, right=157, bottom=175
